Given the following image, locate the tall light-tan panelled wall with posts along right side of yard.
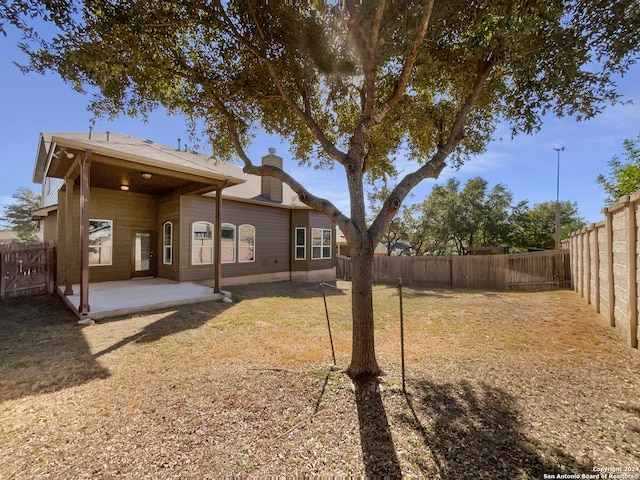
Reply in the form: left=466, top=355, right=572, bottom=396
left=569, top=191, right=640, bottom=348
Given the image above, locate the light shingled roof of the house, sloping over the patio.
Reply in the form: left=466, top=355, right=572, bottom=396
left=33, top=132, right=308, bottom=208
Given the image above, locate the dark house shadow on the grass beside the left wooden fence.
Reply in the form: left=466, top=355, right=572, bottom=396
left=0, top=295, right=109, bottom=402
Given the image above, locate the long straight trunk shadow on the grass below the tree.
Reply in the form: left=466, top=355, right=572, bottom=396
left=355, top=381, right=402, bottom=478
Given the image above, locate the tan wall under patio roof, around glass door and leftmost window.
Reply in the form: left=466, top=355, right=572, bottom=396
left=58, top=186, right=158, bottom=283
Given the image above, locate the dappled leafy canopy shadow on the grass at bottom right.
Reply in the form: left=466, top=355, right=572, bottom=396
left=399, top=381, right=592, bottom=480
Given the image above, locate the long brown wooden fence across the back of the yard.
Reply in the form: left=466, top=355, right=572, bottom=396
left=337, top=251, right=571, bottom=290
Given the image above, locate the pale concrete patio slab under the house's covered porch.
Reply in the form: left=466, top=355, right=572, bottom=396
left=58, top=278, right=230, bottom=320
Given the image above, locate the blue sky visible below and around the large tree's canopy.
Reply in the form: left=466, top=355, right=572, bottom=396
left=0, top=25, right=640, bottom=228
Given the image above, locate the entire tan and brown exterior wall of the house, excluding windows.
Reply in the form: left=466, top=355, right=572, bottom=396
left=52, top=186, right=336, bottom=285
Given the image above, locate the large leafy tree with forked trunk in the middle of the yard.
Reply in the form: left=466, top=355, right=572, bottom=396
left=6, top=0, right=640, bottom=377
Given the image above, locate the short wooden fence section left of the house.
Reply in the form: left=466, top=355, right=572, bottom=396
left=0, top=243, right=55, bottom=300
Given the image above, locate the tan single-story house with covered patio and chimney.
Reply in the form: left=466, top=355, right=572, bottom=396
left=33, top=132, right=335, bottom=316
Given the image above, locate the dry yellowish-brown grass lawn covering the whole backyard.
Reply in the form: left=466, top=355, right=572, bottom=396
left=0, top=282, right=640, bottom=480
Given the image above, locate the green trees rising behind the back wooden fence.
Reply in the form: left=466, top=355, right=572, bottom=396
left=402, top=177, right=586, bottom=255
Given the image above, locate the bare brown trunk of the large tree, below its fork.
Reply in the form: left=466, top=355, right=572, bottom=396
left=347, top=247, right=382, bottom=380
